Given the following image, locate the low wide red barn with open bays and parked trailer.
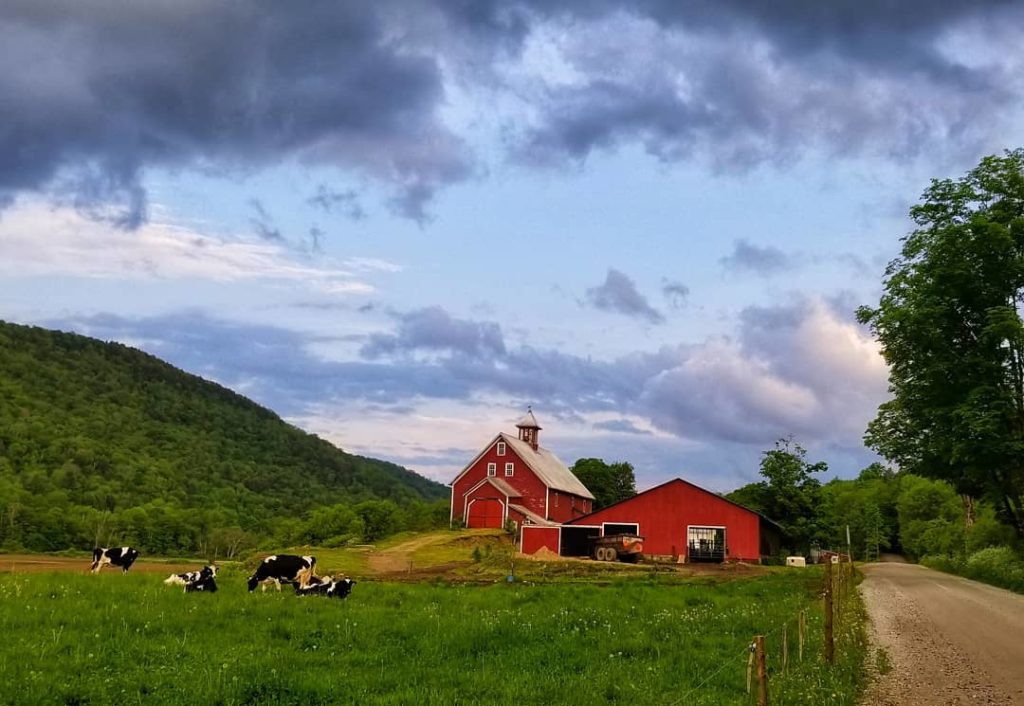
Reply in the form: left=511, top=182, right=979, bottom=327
left=521, top=479, right=781, bottom=562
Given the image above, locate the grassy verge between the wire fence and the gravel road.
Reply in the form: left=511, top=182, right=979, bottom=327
left=670, top=554, right=867, bottom=706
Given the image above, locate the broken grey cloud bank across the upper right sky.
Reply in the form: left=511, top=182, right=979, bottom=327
left=507, top=0, right=1024, bottom=169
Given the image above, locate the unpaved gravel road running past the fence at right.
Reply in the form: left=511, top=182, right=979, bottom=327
left=861, top=563, right=1024, bottom=706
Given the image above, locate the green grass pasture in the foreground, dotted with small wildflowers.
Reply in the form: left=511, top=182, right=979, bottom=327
left=0, top=570, right=863, bottom=706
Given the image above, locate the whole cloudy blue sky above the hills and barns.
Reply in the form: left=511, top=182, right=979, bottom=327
left=0, top=0, right=1024, bottom=490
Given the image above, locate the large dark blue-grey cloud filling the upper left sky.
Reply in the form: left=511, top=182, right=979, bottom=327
left=0, top=0, right=470, bottom=226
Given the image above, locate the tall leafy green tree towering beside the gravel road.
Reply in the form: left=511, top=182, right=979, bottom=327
left=858, top=150, right=1024, bottom=536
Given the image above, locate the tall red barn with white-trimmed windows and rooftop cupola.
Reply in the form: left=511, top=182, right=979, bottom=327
left=452, top=411, right=594, bottom=528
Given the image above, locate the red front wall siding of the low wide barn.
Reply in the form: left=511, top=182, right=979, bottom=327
left=568, top=479, right=762, bottom=562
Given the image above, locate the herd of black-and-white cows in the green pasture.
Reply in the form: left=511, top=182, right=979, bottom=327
left=90, top=547, right=355, bottom=598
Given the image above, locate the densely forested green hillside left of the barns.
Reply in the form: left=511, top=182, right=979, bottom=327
left=0, top=322, right=447, bottom=551
